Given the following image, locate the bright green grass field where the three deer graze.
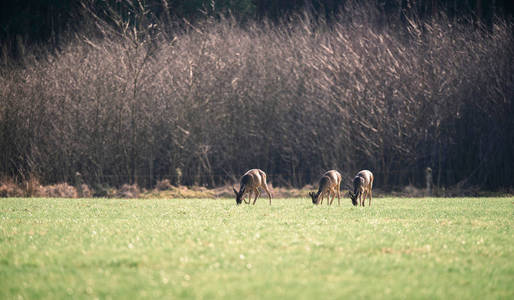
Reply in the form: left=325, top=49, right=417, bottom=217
left=0, top=198, right=514, bottom=300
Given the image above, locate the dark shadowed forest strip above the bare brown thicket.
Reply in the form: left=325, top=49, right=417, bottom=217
left=0, top=0, right=514, bottom=56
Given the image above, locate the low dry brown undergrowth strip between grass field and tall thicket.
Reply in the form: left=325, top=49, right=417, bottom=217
left=0, top=178, right=504, bottom=199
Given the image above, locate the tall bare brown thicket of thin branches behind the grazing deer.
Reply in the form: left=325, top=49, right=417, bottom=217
left=0, top=1, right=514, bottom=190
